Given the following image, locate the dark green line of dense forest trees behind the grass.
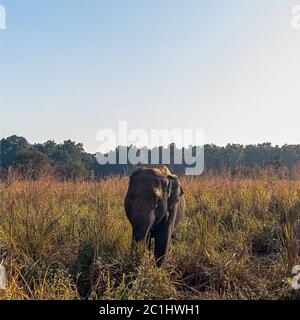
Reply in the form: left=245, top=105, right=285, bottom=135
left=0, top=136, right=300, bottom=179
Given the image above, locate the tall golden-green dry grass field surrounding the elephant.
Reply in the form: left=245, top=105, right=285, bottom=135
left=0, top=177, right=300, bottom=299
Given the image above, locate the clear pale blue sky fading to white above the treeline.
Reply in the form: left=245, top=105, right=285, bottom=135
left=0, top=0, right=300, bottom=152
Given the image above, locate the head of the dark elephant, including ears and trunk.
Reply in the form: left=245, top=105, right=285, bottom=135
left=125, top=166, right=183, bottom=241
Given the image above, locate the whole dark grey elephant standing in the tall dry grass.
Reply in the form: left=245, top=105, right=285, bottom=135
left=125, top=166, right=185, bottom=266
